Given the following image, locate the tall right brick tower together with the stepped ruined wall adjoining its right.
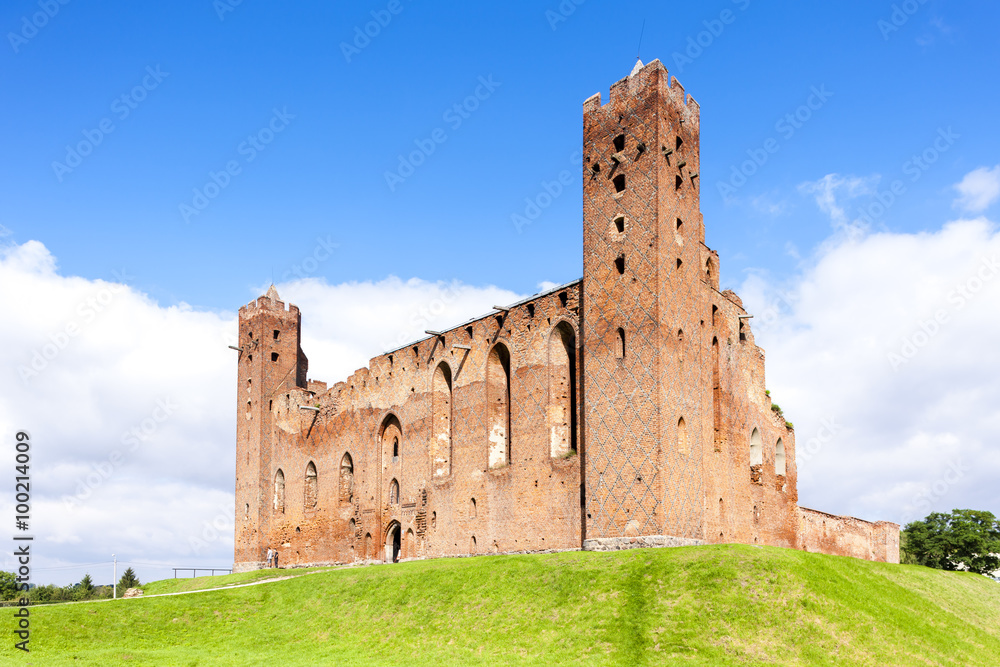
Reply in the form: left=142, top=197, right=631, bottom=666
left=583, top=61, right=797, bottom=546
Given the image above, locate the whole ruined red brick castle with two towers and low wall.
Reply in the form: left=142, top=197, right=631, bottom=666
left=235, top=61, right=899, bottom=570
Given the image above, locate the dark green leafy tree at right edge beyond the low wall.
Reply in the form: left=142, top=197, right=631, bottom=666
left=903, top=510, right=1000, bottom=575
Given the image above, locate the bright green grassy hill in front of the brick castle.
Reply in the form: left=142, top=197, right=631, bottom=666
left=7, top=545, right=1000, bottom=667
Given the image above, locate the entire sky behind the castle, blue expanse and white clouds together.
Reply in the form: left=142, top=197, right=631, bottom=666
left=0, top=0, right=1000, bottom=583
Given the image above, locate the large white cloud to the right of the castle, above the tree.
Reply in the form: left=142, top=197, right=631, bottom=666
left=740, top=219, right=1000, bottom=521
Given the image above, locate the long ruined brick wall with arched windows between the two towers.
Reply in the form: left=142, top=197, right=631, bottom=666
left=254, top=284, right=582, bottom=565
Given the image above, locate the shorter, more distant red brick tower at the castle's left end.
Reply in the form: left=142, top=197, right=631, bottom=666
left=235, top=285, right=309, bottom=569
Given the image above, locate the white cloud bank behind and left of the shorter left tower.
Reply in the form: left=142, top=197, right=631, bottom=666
left=0, top=241, right=520, bottom=583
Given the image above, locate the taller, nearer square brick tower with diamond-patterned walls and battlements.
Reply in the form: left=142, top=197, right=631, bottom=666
left=582, top=60, right=712, bottom=541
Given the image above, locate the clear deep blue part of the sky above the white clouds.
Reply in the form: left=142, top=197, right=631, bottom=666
left=0, top=0, right=1000, bottom=309
